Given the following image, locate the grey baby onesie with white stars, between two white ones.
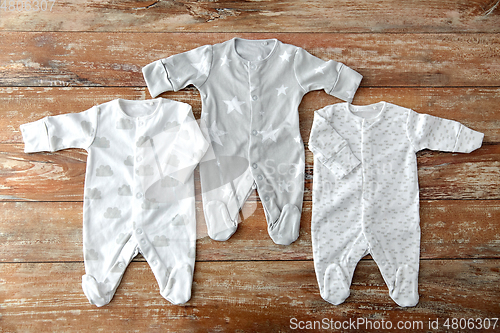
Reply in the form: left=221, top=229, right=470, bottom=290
left=143, top=38, right=362, bottom=245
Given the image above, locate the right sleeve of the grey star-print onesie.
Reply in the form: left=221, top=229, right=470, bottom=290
left=293, top=48, right=363, bottom=102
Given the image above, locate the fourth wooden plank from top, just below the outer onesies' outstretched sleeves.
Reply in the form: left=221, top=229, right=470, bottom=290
left=0, top=144, right=500, bottom=201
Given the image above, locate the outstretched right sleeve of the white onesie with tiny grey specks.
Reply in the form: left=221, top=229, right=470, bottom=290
left=406, top=110, right=484, bottom=153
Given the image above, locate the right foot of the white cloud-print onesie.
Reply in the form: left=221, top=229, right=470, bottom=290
left=161, top=264, right=193, bottom=304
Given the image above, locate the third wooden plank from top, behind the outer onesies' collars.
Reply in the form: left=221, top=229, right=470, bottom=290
left=0, top=87, right=500, bottom=143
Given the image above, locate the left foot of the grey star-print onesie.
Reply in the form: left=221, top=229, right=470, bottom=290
left=204, top=200, right=237, bottom=241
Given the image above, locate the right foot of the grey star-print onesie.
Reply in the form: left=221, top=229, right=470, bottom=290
left=267, top=204, right=301, bottom=245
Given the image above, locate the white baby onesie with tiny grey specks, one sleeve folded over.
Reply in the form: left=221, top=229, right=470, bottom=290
left=309, top=102, right=484, bottom=306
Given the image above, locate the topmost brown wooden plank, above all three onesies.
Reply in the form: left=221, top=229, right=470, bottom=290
left=0, top=0, right=500, bottom=32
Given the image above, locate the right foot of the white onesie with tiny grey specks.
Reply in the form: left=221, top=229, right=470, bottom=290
left=389, top=265, right=418, bottom=307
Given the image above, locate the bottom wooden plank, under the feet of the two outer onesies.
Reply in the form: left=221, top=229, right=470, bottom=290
left=0, top=260, right=500, bottom=332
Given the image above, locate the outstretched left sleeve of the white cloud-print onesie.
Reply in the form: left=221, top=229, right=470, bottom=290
left=20, top=107, right=98, bottom=153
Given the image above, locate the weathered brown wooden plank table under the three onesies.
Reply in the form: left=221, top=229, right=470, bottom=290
left=0, top=0, right=500, bottom=332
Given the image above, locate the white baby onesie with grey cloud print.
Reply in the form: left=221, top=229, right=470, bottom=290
left=21, top=98, right=209, bottom=306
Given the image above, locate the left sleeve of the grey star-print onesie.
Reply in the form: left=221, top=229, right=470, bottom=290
left=142, top=45, right=212, bottom=97
